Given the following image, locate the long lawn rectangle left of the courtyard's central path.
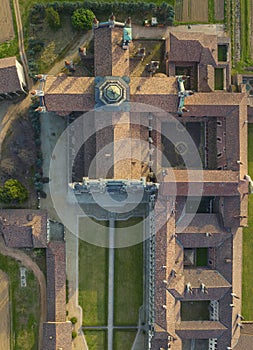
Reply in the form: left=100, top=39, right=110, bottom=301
left=79, top=226, right=108, bottom=326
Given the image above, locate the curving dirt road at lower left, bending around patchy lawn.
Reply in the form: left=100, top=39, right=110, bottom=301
left=0, top=237, right=46, bottom=350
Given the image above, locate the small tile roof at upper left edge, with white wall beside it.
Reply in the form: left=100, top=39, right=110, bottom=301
left=0, top=57, right=21, bottom=94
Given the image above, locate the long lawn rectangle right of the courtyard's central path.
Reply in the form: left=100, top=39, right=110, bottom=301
left=114, top=218, right=143, bottom=326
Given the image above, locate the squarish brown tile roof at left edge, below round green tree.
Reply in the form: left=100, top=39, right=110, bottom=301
left=0, top=209, right=47, bottom=248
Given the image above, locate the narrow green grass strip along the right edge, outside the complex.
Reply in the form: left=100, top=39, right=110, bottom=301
left=242, top=124, right=253, bottom=321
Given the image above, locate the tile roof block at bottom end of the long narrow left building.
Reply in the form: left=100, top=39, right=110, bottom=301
left=42, top=322, right=72, bottom=350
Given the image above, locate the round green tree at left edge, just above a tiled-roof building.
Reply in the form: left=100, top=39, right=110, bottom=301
left=0, top=179, right=28, bottom=203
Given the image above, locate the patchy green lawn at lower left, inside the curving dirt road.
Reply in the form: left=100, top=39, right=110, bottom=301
left=0, top=254, right=40, bottom=350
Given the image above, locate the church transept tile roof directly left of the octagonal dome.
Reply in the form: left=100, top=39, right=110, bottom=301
left=44, top=76, right=95, bottom=112
